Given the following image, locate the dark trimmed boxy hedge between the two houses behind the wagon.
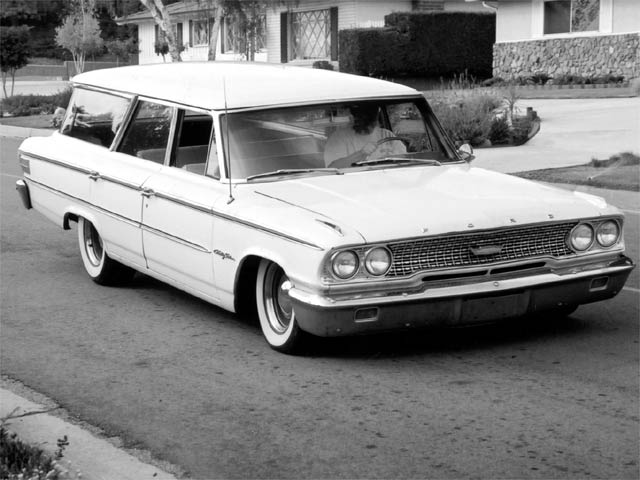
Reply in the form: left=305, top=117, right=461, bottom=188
left=339, top=12, right=496, bottom=78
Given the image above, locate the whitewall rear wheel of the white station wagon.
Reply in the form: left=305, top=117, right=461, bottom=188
left=78, top=217, right=135, bottom=285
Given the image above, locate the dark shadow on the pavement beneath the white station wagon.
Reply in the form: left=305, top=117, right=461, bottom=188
left=120, top=273, right=596, bottom=359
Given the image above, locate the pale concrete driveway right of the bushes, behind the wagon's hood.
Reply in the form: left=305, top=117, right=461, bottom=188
left=473, top=97, right=640, bottom=173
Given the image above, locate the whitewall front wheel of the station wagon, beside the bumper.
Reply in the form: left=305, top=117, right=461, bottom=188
left=256, top=260, right=306, bottom=353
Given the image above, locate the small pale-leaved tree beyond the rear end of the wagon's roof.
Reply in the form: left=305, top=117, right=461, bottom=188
left=56, top=0, right=104, bottom=73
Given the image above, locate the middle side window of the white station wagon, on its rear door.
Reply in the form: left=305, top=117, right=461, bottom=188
left=118, top=101, right=173, bottom=163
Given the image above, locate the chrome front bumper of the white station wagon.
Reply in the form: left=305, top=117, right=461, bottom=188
left=289, top=255, right=634, bottom=337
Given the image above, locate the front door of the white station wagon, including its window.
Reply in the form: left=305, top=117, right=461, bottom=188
left=142, top=109, right=224, bottom=299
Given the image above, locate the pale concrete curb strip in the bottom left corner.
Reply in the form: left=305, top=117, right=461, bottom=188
left=0, top=388, right=176, bottom=480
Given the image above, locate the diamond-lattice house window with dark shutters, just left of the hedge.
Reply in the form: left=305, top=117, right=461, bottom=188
left=280, top=7, right=338, bottom=62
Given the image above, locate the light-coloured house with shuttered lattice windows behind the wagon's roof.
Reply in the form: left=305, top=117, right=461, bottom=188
left=118, top=0, right=486, bottom=66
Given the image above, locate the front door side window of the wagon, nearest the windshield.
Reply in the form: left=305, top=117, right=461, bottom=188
left=171, top=110, right=218, bottom=175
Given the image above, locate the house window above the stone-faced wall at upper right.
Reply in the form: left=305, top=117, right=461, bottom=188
left=544, top=0, right=600, bottom=34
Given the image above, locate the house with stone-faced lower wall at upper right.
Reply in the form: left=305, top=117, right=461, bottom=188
left=492, top=0, right=640, bottom=79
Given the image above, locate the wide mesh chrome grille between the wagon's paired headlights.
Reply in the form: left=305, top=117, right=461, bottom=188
left=386, top=222, right=577, bottom=277
